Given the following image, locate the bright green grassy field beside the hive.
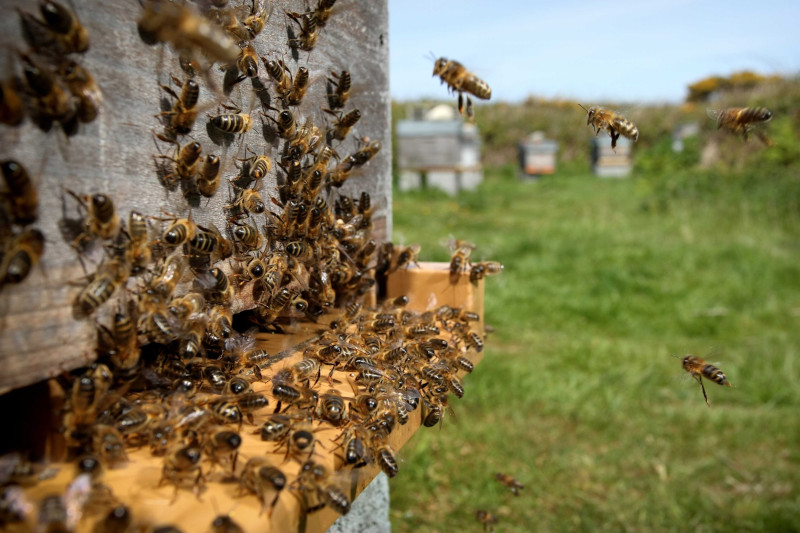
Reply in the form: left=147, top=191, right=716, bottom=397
left=391, top=164, right=800, bottom=533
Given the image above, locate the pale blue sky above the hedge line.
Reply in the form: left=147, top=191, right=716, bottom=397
left=389, top=0, right=800, bottom=103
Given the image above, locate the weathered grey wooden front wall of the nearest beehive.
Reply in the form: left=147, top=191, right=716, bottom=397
left=0, top=0, right=391, bottom=393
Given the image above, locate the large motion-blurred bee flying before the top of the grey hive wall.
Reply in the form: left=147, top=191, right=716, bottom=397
left=137, top=0, right=239, bottom=65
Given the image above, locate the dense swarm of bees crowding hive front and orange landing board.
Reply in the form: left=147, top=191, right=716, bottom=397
left=0, top=0, right=500, bottom=531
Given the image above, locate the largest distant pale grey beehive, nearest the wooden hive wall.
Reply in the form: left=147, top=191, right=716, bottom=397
left=396, top=106, right=483, bottom=194
